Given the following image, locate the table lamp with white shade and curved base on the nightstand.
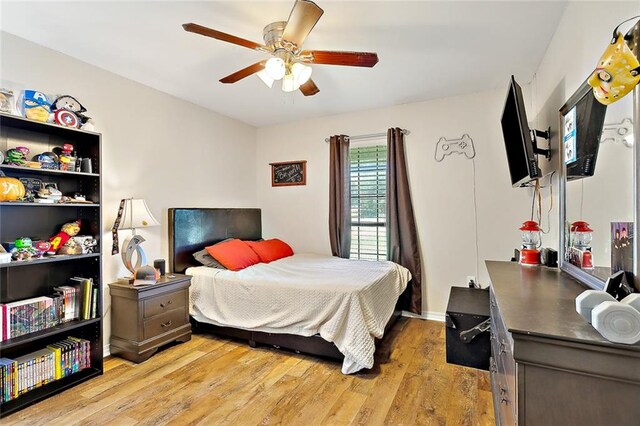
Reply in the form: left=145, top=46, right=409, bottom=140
left=112, top=198, right=160, bottom=274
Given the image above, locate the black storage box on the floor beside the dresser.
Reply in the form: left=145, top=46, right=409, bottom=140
left=446, top=287, right=491, bottom=370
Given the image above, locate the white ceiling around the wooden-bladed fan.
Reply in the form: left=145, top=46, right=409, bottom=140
left=0, top=0, right=566, bottom=126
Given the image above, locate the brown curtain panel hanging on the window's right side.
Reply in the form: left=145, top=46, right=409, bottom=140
left=387, top=127, right=422, bottom=314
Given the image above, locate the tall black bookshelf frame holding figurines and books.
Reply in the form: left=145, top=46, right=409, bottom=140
left=0, top=114, right=103, bottom=417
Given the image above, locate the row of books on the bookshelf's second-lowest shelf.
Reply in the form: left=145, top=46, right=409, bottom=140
left=0, top=277, right=99, bottom=341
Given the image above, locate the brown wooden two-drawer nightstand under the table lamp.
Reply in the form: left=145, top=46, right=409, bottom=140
left=109, top=274, right=191, bottom=362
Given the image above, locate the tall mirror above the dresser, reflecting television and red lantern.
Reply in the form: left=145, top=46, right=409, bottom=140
left=559, top=22, right=640, bottom=291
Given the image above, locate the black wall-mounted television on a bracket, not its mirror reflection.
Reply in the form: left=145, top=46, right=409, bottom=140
left=501, top=76, right=542, bottom=187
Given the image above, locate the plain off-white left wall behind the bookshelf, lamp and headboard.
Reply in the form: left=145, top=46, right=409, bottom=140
left=0, top=32, right=256, bottom=344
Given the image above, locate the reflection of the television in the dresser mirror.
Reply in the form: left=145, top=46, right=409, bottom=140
left=560, top=81, right=607, bottom=180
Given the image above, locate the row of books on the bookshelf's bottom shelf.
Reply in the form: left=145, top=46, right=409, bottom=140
left=0, top=337, right=91, bottom=404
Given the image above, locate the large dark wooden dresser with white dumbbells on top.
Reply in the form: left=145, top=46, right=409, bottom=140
left=486, top=261, right=640, bottom=426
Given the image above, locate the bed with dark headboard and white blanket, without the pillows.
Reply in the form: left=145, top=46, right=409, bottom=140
left=169, top=208, right=410, bottom=374
